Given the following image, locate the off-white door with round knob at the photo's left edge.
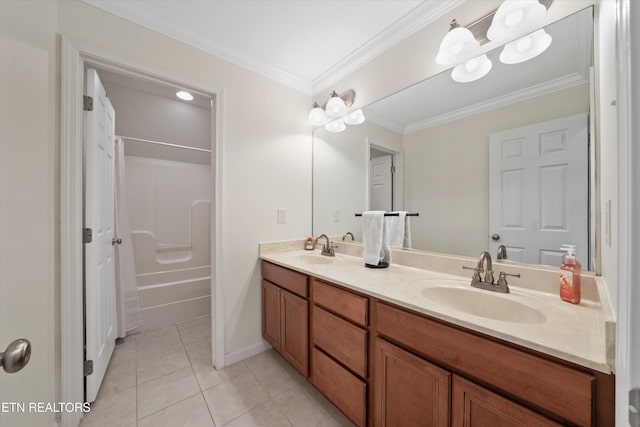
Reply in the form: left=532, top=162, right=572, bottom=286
left=0, top=31, right=56, bottom=427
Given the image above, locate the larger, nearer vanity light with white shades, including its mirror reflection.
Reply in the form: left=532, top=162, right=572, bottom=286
left=435, top=0, right=553, bottom=83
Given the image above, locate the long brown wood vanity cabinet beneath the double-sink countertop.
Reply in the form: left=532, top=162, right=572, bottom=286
left=262, top=262, right=615, bottom=427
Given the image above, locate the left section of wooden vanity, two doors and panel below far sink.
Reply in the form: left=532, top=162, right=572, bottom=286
left=262, top=262, right=309, bottom=377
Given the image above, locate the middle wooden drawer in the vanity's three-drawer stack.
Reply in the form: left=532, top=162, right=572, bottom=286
left=311, top=306, right=368, bottom=378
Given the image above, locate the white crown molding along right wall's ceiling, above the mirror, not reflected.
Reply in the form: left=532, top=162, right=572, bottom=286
left=311, top=0, right=465, bottom=95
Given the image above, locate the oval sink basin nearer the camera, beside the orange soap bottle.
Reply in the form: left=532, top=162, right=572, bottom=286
left=421, top=286, right=547, bottom=324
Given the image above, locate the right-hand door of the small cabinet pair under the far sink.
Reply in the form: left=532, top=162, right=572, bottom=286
left=280, top=289, right=309, bottom=377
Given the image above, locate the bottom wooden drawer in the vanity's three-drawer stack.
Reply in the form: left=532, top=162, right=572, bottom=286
left=311, top=348, right=367, bottom=426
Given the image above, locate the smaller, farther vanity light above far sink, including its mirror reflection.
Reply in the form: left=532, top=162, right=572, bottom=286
left=307, top=90, right=365, bottom=132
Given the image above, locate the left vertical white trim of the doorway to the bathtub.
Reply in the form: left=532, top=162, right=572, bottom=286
left=60, top=37, right=84, bottom=427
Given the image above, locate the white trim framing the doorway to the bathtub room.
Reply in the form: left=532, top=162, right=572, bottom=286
left=60, top=37, right=225, bottom=427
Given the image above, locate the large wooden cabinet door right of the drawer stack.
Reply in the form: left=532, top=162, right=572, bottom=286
left=374, top=338, right=450, bottom=427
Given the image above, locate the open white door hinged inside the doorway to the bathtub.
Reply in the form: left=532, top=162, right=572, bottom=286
left=84, top=69, right=117, bottom=402
